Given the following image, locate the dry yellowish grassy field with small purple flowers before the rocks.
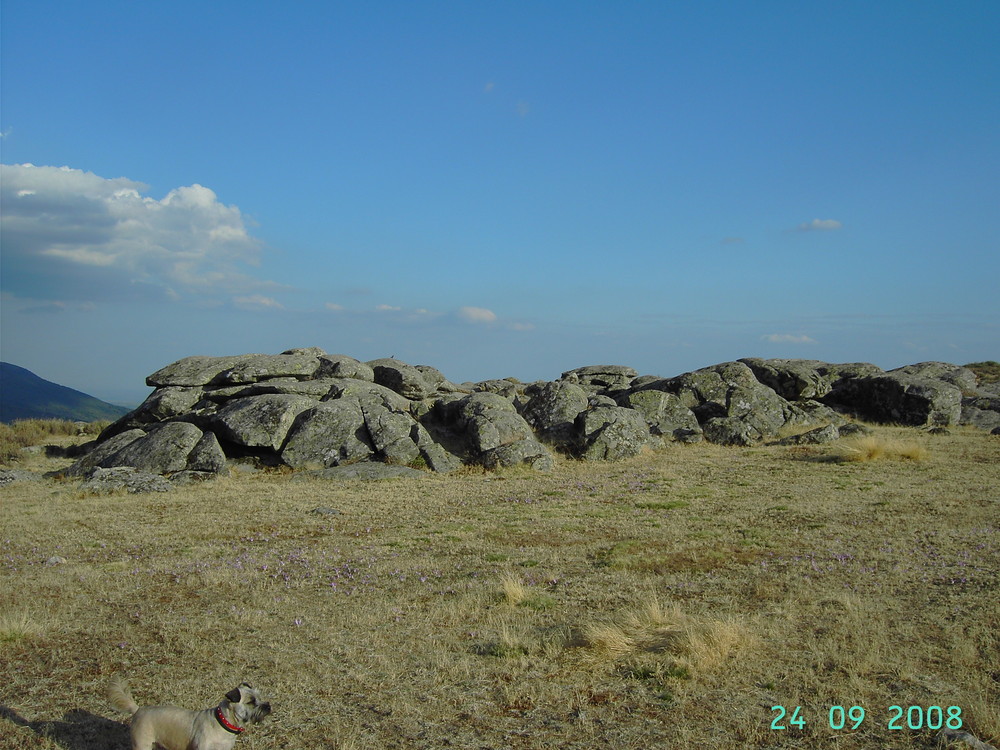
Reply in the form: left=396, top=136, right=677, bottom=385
left=0, top=427, right=1000, bottom=750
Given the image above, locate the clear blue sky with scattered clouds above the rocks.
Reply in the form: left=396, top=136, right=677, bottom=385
left=0, top=0, right=1000, bottom=402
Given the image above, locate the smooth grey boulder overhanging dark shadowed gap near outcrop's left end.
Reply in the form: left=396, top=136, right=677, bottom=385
left=209, top=393, right=316, bottom=451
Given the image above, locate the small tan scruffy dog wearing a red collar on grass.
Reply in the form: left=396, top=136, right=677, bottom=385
left=108, top=677, right=271, bottom=750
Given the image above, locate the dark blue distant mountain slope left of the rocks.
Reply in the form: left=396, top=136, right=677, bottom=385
left=0, top=362, right=130, bottom=422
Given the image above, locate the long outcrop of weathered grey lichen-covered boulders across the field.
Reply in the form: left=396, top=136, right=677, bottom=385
left=62, top=347, right=1000, bottom=488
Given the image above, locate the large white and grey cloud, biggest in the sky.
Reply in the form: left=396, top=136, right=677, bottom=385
left=0, top=164, right=274, bottom=299
